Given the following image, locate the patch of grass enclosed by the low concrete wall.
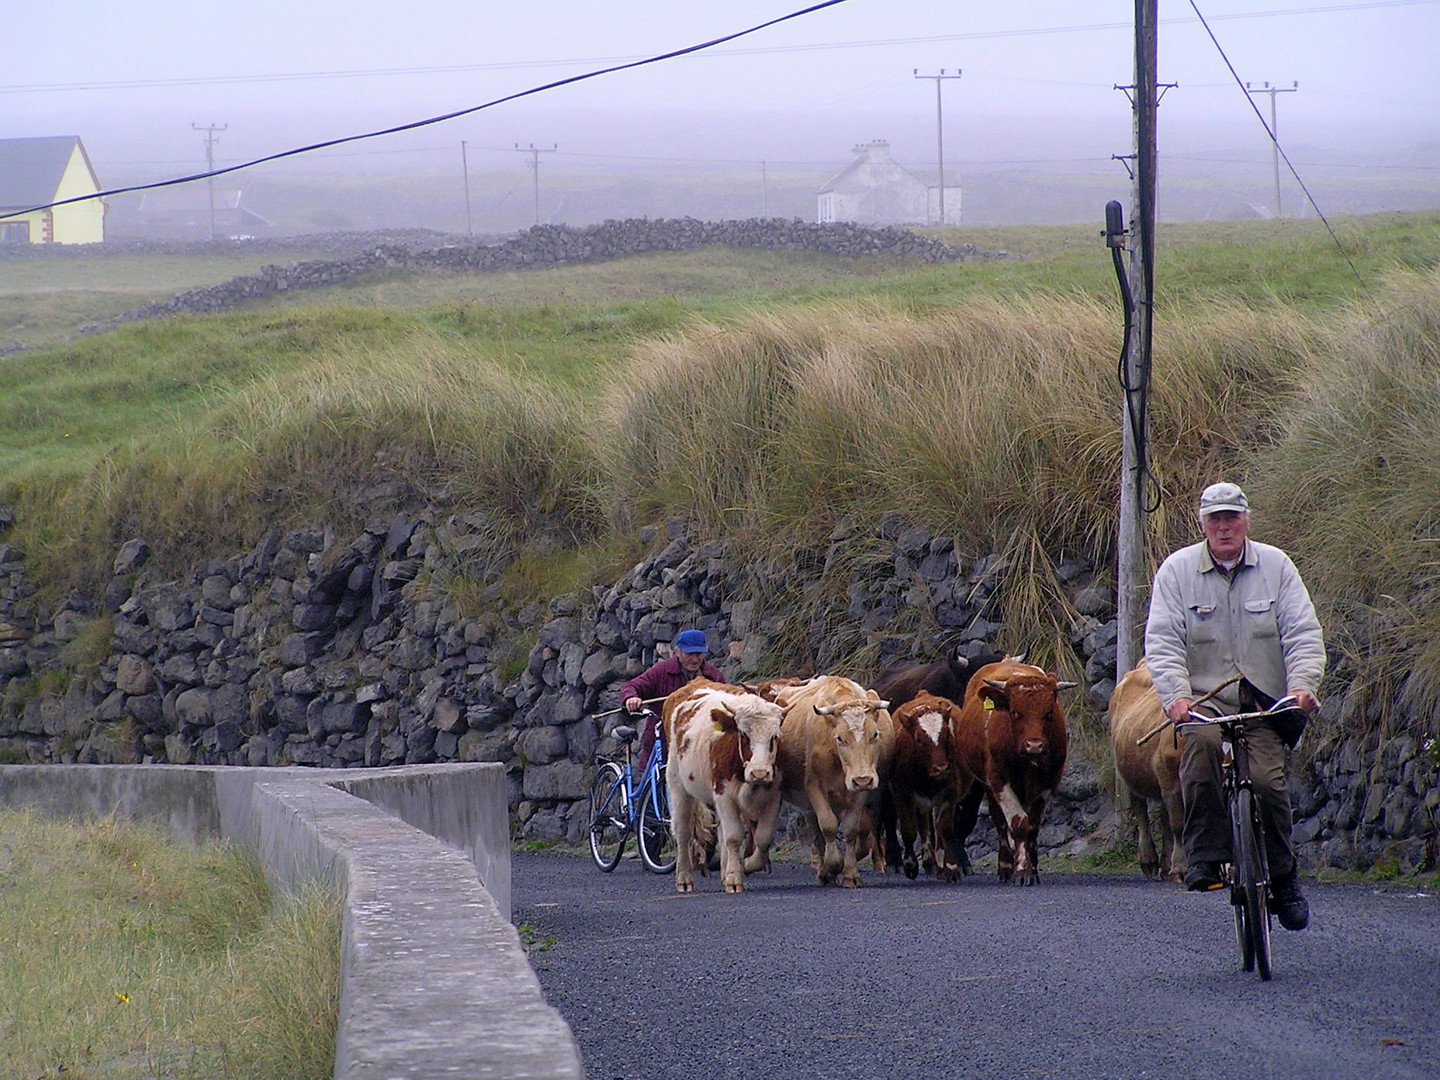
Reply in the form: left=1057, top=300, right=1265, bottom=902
left=0, top=811, right=340, bottom=1080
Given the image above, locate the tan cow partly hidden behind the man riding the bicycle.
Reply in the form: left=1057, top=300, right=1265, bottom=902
left=1110, top=657, right=1185, bottom=881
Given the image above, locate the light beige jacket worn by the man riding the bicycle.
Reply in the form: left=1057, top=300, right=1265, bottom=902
left=1145, top=540, right=1325, bottom=708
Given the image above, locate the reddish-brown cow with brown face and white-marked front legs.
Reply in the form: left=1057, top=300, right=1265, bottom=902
left=956, top=660, right=1076, bottom=886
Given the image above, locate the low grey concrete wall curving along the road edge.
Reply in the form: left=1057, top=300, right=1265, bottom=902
left=0, top=765, right=582, bottom=1080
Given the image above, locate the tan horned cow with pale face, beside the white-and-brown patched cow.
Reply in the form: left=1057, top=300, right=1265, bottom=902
left=776, top=675, right=894, bottom=888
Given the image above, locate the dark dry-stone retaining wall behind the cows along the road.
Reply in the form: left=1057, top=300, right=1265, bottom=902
left=0, top=514, right=1440, bottom=868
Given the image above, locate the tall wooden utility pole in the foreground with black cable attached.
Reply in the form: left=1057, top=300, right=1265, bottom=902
left=1115, top=0, right=1159, bottom=677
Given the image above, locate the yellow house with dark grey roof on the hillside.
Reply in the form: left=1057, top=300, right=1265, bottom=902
left=0, top=135, right=105, bottom=243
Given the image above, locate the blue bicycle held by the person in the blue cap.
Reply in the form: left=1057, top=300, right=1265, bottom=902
left=590, top=708, right=675, bottom=874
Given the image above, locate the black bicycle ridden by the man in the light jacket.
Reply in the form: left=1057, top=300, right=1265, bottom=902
left=1175, top=697, right=1300, bottom=981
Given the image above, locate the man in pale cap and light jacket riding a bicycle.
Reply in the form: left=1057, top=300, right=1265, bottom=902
left=1145, top=484, right=1325, bottom=930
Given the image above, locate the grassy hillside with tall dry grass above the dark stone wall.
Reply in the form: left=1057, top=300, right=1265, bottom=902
left=0, top=215, right=1440, bottom=737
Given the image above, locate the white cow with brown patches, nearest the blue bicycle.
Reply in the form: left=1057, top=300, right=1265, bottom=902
left=661, top=680, right=782, bottom=893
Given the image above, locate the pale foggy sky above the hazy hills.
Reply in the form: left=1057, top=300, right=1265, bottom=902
left=0, top=0, right=1440, bottom=198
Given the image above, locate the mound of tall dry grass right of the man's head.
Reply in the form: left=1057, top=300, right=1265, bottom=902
left=1246, top=271, right=1440, bottom=734
